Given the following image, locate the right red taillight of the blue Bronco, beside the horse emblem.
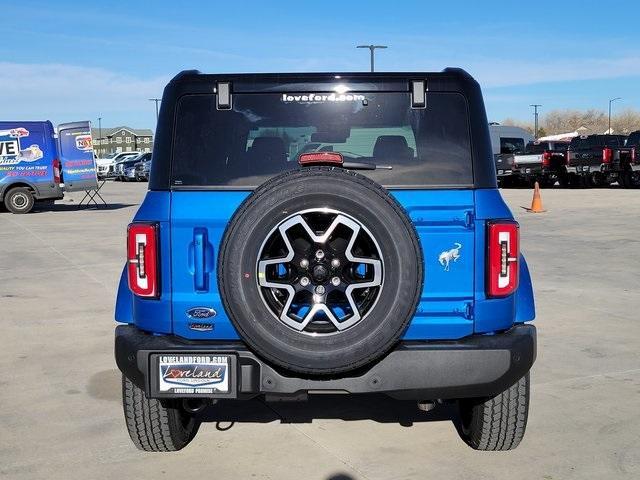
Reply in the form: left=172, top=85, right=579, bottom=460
left=487, top=221, right=520, bottom=297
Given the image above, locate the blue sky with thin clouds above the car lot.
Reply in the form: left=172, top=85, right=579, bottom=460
left=0, top=0, right=640, bottom=128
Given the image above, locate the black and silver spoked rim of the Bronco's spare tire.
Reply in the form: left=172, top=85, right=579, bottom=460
left=256, top=208, right=384, bottom=336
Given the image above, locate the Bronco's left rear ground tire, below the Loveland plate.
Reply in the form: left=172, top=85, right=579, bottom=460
left=122, top=375, right=200, bottom=452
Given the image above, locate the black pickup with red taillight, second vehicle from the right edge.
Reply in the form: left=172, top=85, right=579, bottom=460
left=567, top=135, right=631, bottom=187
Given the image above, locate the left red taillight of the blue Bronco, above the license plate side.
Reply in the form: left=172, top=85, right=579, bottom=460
left=127, top=223, right=160, bottom=298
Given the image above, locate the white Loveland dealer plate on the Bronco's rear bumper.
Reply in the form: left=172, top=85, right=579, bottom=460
left=158, top=353, right=232, bottom=395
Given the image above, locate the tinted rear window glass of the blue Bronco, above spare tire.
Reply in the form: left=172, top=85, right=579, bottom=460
left=171, top=92, right=473, bottom=188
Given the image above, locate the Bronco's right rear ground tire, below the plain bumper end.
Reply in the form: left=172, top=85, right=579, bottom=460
left=458, top=372, right=529, bottom=450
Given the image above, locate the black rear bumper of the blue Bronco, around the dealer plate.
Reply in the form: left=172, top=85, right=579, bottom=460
left=115, top=324, right=536, bottom=399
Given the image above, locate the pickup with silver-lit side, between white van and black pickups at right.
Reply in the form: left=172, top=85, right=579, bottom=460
left=513, top=141, right=569, bottom=187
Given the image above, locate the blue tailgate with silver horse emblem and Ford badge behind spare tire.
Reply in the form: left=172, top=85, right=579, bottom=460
left=171, top=190, right=475, bottom=340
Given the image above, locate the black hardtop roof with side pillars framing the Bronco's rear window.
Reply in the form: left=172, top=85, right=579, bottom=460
left=149, top=68, right=496, bottom=190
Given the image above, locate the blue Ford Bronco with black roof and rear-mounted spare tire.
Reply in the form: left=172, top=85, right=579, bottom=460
left=115, top=68, right=536, bottom=451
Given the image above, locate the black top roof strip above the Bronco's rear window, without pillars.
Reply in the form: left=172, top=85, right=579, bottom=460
left=169, top=68, right=477, bottom=93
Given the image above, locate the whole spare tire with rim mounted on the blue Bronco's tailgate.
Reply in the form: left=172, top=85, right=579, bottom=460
left=218, top=167, right=423, bottom=374
